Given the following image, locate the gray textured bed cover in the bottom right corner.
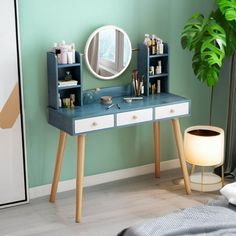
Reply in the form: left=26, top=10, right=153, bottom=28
left=122, top=200, right=236, bottom=236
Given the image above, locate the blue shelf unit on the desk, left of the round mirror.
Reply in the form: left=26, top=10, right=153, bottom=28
left=47, top=51, right=83, bottom=109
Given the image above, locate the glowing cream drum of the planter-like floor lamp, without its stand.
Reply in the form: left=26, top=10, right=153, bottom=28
left=184, top=126, right=224, bottom=166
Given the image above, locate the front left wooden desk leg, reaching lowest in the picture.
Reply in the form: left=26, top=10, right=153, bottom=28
left=75, top=135, right=85, bottom=223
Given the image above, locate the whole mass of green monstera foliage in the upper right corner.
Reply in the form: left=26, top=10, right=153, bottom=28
left=181, top=0, right=236, bottom=87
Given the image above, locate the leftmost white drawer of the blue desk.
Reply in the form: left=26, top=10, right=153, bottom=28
left=75, top=115, right=114, bottom=133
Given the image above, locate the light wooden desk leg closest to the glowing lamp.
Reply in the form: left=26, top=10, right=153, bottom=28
left=172, top=119, right=191, bottom=194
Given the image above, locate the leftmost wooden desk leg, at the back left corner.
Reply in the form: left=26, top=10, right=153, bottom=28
left=49, top=131, right=67, bottom=202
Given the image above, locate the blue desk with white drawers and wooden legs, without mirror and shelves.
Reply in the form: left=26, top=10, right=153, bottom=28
left=49, top=90, right=191, bottom=222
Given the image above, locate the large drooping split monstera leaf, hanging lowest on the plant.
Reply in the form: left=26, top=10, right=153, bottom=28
left=181, top=13, right=226, bottom=86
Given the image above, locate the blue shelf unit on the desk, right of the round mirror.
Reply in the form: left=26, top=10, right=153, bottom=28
left=138, top=43, right=169, bottom=96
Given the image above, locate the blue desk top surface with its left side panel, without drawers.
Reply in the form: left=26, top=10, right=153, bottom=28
left=48, top=93, right=190, bottom=135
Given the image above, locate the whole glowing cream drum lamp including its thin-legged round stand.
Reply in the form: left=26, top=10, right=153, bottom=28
left=184, top=126, right=224, bottom=192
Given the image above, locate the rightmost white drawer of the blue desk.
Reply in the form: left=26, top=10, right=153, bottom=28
left=155, top=102, right=189, bottom=120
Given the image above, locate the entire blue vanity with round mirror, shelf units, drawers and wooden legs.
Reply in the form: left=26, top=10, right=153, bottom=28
left=47, top=25, right=191, bottom=222
